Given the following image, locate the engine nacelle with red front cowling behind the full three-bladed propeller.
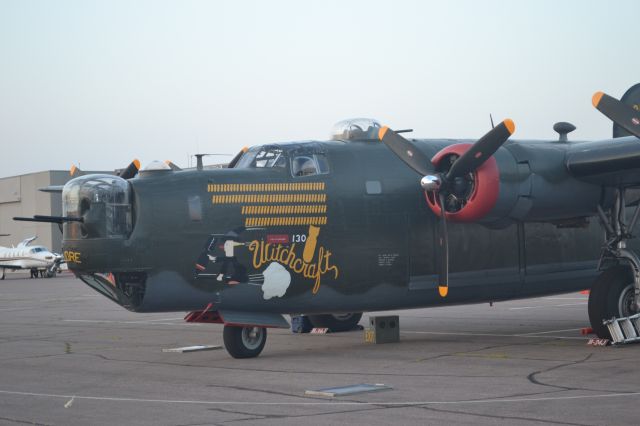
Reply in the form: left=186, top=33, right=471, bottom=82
left=426, top=142, right=612, bottom=228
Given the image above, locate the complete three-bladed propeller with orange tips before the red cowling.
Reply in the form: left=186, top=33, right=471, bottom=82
left=378, top=119, right=515, bottom=297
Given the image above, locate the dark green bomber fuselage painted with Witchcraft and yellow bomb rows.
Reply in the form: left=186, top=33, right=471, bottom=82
left=63, top=140, right=602, bottom=313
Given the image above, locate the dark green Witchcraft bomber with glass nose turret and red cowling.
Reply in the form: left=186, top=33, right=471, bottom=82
left=17, top=84, right=640, bottom=358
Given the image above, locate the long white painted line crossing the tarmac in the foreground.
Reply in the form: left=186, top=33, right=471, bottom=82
left=0, top=390, right=640, bottom=406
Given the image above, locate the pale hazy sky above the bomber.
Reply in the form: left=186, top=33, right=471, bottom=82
left=0, top=0, right=640, bottom=176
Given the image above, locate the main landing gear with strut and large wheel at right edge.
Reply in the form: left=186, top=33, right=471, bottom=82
left=588, top=188, right=640, bottom=339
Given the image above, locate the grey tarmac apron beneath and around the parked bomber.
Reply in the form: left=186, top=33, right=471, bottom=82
left=0, top=274, right=640, bottom=425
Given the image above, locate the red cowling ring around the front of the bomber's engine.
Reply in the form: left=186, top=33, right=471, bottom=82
left=425, top=143, right=500, bottom=222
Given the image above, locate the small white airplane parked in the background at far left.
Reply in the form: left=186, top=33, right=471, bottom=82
left=0, top=237, right=63, bottom=280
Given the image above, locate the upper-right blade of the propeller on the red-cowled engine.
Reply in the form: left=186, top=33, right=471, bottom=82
left=445, top=118, right=516, bottom=181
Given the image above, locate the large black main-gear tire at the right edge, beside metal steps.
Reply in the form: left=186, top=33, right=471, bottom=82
left=588, top=266, right=636, bottom=339
